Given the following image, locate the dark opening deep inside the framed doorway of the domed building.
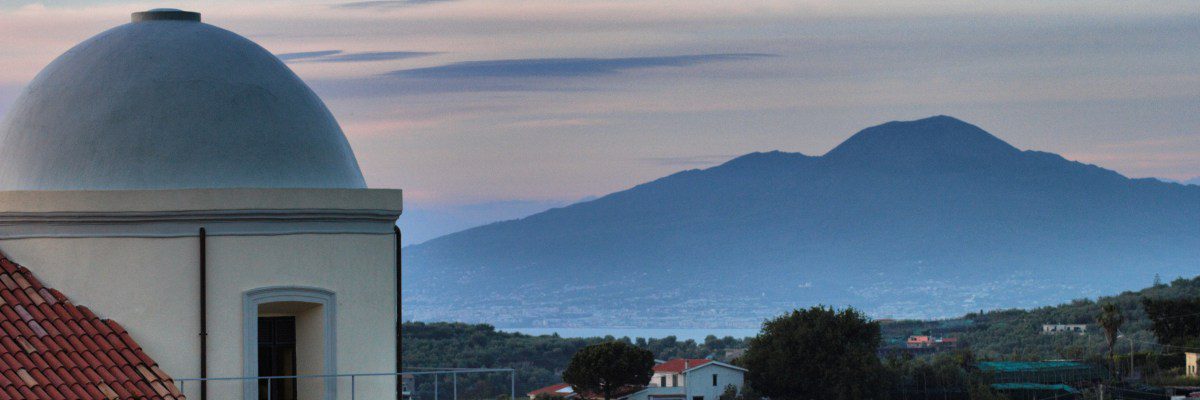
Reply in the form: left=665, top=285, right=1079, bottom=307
left=258, top=317, right=296, bottom=400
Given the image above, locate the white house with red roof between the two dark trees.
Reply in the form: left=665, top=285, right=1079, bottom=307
left=626, top=358, right=746, bottom=400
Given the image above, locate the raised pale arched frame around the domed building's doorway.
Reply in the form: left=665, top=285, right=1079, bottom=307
left=241, top=286, right=337, bottom=400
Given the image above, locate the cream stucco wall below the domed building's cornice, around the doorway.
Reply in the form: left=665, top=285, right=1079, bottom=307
left=0, top=230, right=396, bottom=399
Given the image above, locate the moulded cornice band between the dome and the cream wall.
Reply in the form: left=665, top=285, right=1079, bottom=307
left=0, top=189, right=403, bottom=239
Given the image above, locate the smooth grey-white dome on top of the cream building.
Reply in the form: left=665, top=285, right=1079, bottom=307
left=0, top=10, right=366, bottom=190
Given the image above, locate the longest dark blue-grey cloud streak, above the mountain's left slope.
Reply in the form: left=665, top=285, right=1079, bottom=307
left=389, top=53, right=773, bottom=79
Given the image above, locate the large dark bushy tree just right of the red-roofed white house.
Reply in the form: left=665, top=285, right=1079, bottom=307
left=742, top=306, right=886, bottom=400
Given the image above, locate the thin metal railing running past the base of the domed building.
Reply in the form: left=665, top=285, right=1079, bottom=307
left=174, top=368, right=517, bottom=400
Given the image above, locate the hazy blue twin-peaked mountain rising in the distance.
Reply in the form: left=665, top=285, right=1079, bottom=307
left=402, top=117, right=1200, bottom=328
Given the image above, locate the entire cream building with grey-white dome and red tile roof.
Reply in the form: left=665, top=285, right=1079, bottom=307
left=0, top=10, right=402, bottom=400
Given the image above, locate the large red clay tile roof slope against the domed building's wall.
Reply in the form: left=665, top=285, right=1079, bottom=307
left=0, top=253, right=184, bottom=400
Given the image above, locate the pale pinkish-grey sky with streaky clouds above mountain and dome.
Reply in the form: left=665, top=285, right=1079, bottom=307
left=0, top=0, right=1200, bottom=237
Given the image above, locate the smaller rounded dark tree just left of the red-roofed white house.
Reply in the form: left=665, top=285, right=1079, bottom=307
left=563, top=341, right=654, bottom=400
